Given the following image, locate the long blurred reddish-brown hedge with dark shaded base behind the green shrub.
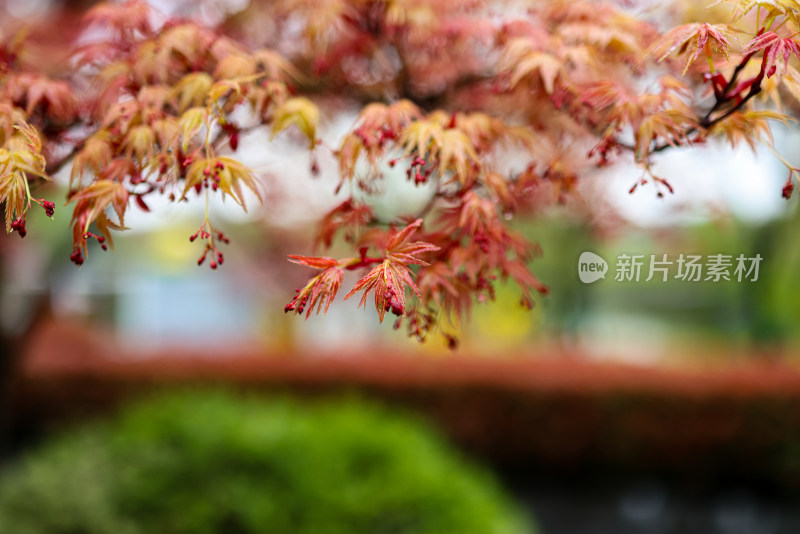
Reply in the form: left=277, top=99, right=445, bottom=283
left=5, top=325, right=800, bottom=534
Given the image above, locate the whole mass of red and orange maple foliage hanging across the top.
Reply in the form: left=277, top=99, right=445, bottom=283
left=0, top=0, right=800, bottom=346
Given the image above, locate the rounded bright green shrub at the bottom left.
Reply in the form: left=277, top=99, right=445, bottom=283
left=0, top=391, right=533, bottom=534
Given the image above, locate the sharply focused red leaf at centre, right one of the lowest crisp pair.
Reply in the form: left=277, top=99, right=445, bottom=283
left=344, top=219, right=439, bottom=322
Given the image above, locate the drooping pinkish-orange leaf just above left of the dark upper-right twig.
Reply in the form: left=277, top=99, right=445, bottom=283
left=648, top=22, right=738, bottom=75
